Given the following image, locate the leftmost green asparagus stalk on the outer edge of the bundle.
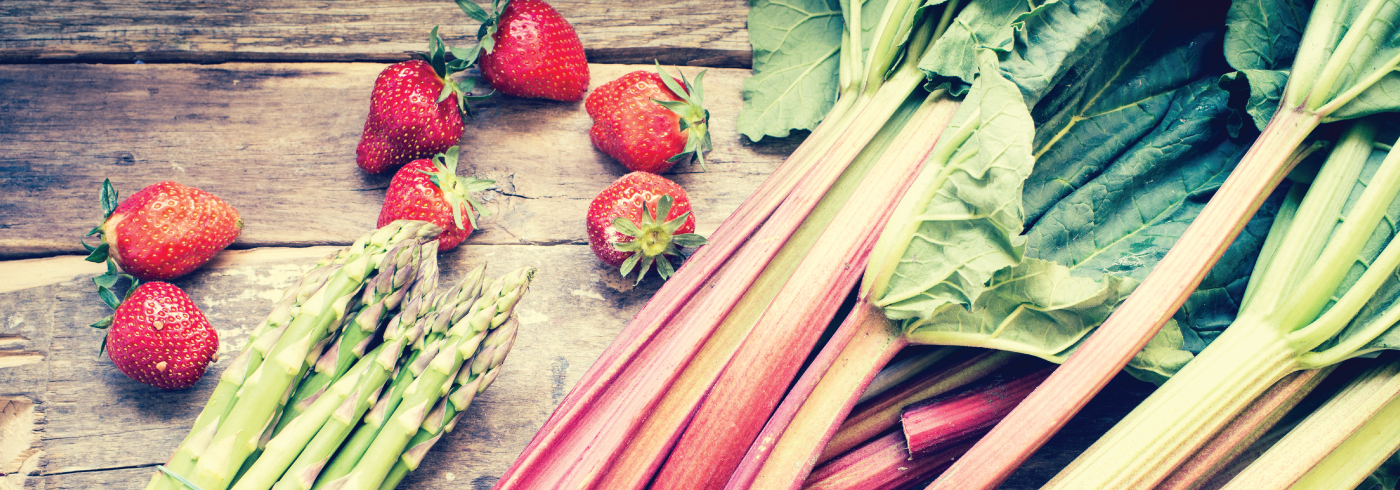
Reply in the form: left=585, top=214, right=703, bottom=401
left=150, top=249, right=368, bottom=489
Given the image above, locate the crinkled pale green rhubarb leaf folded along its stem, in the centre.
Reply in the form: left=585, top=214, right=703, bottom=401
left=865, top=50, right=1035, bottom=319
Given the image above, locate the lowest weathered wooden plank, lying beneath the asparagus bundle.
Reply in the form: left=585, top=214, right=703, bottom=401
left=0, top=245, right=657, bottom=489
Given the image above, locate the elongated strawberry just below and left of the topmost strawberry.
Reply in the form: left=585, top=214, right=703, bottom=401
left=356, top=28, right=487, bottom=174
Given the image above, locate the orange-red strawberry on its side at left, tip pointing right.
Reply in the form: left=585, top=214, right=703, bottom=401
left=83, top=181, right=244, bottom=286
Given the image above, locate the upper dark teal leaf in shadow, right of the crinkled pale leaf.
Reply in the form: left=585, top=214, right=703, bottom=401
left=1025, top=26, right=1219, bottom=223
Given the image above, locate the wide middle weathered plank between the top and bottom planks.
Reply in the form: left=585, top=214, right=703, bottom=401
left=0, top=63, right=794, bottom=259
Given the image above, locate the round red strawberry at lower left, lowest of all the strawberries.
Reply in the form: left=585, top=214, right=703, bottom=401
left=106, top=283, right=218, bottom=389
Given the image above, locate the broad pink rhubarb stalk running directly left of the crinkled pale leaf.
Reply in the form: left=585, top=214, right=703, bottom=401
left=655, top=88, right=958, bottom=489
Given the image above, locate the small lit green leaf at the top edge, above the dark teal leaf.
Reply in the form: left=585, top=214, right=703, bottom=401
left=1001, top=0, right=1151, bottom=106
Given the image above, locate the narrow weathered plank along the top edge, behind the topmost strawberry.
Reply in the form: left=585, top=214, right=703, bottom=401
left=0, top=0, right=753, bottom=67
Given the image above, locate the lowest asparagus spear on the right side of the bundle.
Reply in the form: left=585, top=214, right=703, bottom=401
left=379, top=318, right=519, bottom=490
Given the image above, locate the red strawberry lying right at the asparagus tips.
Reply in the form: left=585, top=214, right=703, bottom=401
left=378, top=147, right=496, bottom=251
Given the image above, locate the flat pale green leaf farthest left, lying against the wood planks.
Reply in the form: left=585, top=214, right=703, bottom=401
left=738, top=0, right=834, bottom=141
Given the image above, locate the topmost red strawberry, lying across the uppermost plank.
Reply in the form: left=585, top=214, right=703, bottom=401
left=456, top=0, right=588, bottom=102
